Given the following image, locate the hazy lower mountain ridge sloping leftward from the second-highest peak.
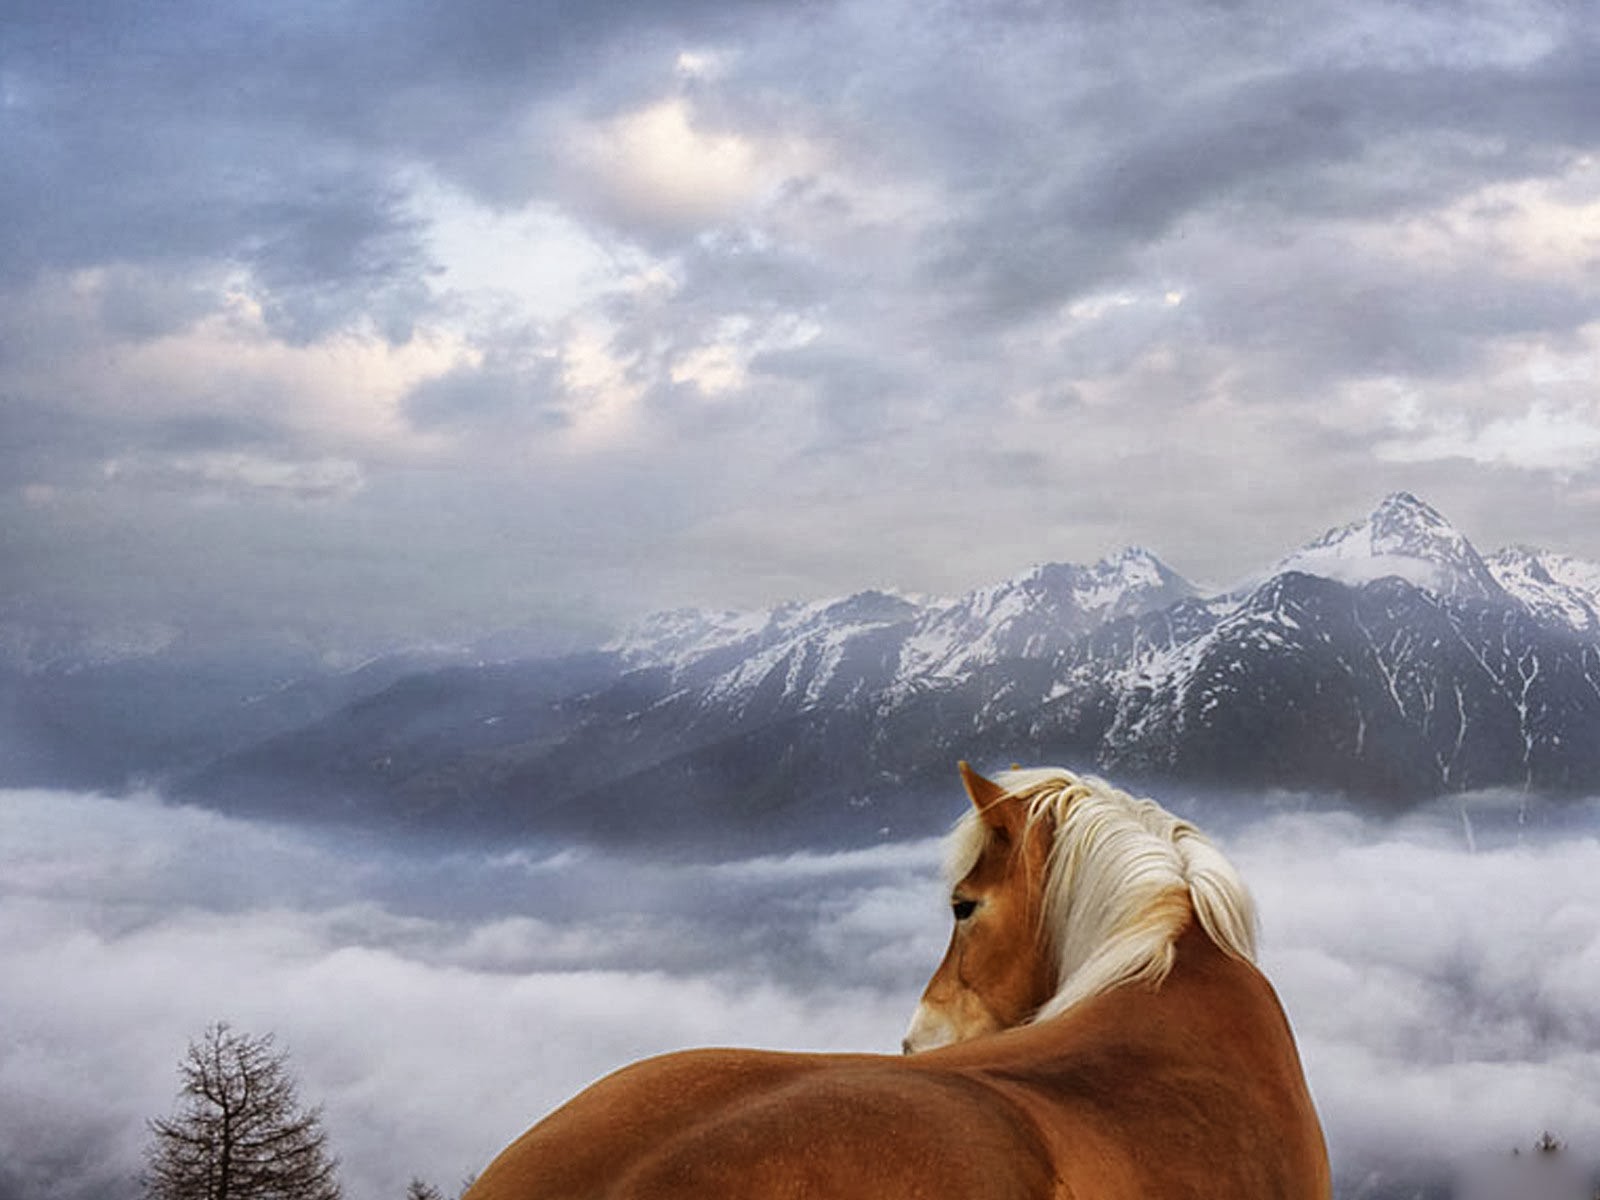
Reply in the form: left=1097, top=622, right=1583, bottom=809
left=178, top=550, right=1194, bottom=840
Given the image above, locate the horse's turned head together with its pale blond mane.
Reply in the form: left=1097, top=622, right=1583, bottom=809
left=902, top=763, right=1254, bottom=1053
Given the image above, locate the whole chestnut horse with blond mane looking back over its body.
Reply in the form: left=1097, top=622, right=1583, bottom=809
left=466, top=763, right=1331, bottom=1200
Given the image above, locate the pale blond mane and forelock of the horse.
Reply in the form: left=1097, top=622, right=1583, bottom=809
left=947, top=766, right=1256, bottom=1021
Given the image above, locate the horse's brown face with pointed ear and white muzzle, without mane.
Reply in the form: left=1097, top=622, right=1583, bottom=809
left=902, top=763, right=1056, bottom=1054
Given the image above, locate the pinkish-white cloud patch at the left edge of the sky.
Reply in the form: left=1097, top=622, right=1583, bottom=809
left=0, top=270, right=477, bottom=493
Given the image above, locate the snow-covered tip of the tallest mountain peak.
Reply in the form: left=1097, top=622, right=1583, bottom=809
left=1272, top=491, right=1502, bottom=600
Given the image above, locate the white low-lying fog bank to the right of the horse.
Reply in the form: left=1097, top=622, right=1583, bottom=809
left=1232, top=816, right=1600, bottom=1184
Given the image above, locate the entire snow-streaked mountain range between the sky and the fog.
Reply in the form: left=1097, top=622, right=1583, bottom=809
left=21, top=493, right=1600, bottom=845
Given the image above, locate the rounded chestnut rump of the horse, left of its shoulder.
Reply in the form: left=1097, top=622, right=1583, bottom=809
left=469, top=1051, right=1058, bottom=1200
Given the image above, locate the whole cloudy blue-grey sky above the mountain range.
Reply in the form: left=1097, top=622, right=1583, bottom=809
left=0, top=0, right=1600, bottom=659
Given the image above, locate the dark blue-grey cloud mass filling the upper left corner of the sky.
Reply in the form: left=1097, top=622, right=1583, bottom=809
left=0, top=3, right=812, bottom=341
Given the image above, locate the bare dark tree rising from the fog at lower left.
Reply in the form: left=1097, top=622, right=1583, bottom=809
left=144, top=1022, right=339, bottom=1200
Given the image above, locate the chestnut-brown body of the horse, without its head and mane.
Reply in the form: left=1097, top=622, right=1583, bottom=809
left=467, top=925, right=1331, bottom=1200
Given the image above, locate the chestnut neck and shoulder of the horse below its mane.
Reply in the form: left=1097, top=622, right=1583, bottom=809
left=941, top=925, right=1330, bottom=1200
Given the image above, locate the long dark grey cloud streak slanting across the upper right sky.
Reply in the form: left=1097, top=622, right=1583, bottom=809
left=928, top=24, right=1600, bottom=322
